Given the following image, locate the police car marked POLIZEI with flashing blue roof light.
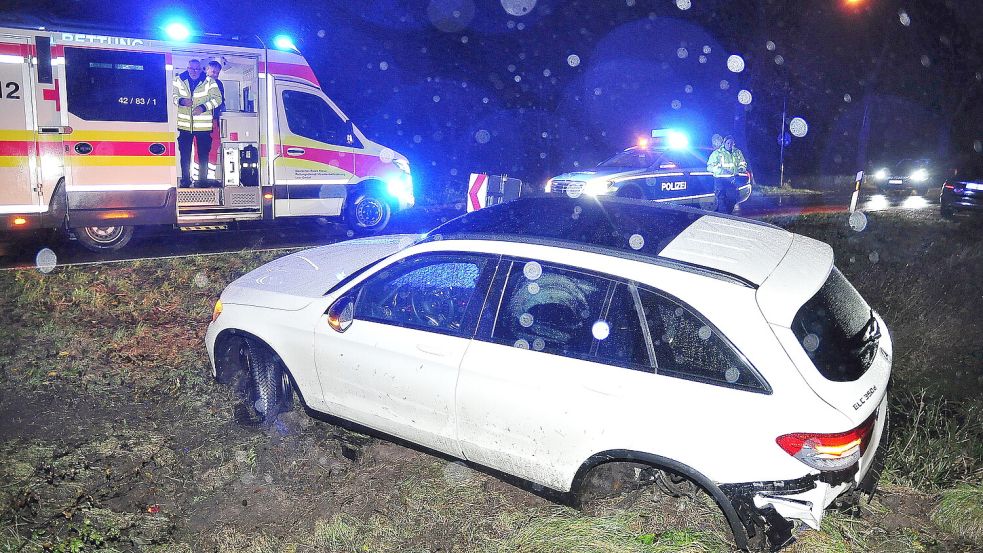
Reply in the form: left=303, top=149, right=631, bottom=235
left=545, top=138, right=751, bottom=210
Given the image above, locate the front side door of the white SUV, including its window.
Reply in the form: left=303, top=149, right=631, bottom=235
left=315, top=252, right=497, bottom=456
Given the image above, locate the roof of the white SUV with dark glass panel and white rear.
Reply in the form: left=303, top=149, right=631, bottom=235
left=424, top=196, right=792, bottom=288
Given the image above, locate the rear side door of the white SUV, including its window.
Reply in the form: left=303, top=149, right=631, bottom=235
left=457, top=260, right=630, bottom=489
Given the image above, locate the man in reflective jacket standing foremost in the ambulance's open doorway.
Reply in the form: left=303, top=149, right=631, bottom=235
left=173, top=59, right=222, bottom=188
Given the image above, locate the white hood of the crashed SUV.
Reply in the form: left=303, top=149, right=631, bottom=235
left=222, top=234, right=420, bottom=311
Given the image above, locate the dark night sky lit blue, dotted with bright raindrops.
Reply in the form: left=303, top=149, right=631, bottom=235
left=0, top=0, right=983, bottom=199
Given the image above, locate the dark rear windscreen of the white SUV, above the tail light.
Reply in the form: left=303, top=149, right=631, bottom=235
left=792, top=267, right=881, bottom=382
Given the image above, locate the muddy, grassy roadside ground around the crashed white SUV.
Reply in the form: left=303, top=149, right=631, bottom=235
left=0, top=205, right=983, bottom=552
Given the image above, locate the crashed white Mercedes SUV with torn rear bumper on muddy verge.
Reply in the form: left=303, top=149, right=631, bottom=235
left=207, top=197, right=892, bottom=548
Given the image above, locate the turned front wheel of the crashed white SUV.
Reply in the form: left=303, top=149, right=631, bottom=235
left=241, top=340, right=293, bottom=423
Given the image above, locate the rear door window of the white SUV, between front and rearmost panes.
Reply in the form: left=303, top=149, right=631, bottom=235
left=492, top=261, right=611, bottom=359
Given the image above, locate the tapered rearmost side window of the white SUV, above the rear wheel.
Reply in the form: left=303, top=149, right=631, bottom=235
left=638, top=289, right=767, bottom=391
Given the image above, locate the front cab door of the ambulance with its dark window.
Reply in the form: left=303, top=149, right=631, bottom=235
left=273, top=81, right=355, bottom=216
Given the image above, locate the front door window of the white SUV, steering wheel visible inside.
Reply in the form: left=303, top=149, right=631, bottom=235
left=355, top=254, right=488, bottom=337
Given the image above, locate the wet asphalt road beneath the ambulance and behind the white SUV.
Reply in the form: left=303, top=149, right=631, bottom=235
left=0, top=194, right=938, bottom=270
